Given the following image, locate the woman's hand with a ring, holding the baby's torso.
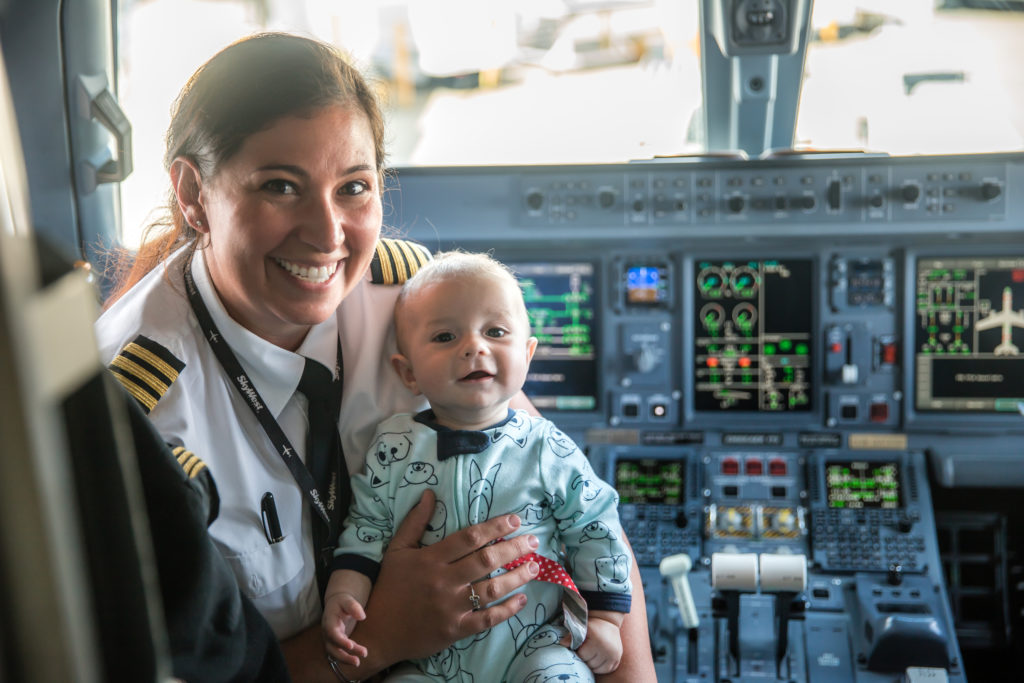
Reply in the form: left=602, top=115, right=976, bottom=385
left=352, top=490, right=539, bottom=676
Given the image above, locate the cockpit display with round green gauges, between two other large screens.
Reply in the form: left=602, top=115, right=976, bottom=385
left=693, top=259, right=815, bottom=412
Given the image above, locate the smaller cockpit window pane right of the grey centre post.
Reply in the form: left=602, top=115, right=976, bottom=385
left=796, top=0, right=1024, bottom=155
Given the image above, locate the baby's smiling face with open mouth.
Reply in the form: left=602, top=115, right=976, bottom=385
left=395, top=278, right=537, bottom=429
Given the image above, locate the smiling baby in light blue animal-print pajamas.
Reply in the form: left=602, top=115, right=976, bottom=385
left=323, top=252, right=631, bottom=681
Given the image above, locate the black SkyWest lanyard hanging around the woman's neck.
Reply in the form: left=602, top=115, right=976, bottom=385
left=184, top=263, right=348, bottom=532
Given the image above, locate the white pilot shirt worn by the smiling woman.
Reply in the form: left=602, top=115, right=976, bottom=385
left=95, top=249, right=425, bottom=639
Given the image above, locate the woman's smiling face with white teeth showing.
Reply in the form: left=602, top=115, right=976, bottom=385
left=199, top=105, right=381, bottom=350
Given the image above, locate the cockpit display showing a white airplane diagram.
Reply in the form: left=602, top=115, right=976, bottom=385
left=914, top=257, right=1024, bottom=414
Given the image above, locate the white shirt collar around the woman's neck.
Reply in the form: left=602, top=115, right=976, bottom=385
left=189, top=250, right=338, bottom=419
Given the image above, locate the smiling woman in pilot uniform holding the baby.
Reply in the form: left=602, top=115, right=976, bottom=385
left=96, top=34, right=653, bottom=681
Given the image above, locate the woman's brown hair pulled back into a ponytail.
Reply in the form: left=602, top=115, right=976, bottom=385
left=106, top=33, right=385, bottom=306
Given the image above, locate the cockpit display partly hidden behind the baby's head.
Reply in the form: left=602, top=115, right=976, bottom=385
left=509, top=262, right=599, bottom=412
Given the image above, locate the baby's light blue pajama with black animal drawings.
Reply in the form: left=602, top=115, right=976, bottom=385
left=334, top=411, right=631, bottom=683
